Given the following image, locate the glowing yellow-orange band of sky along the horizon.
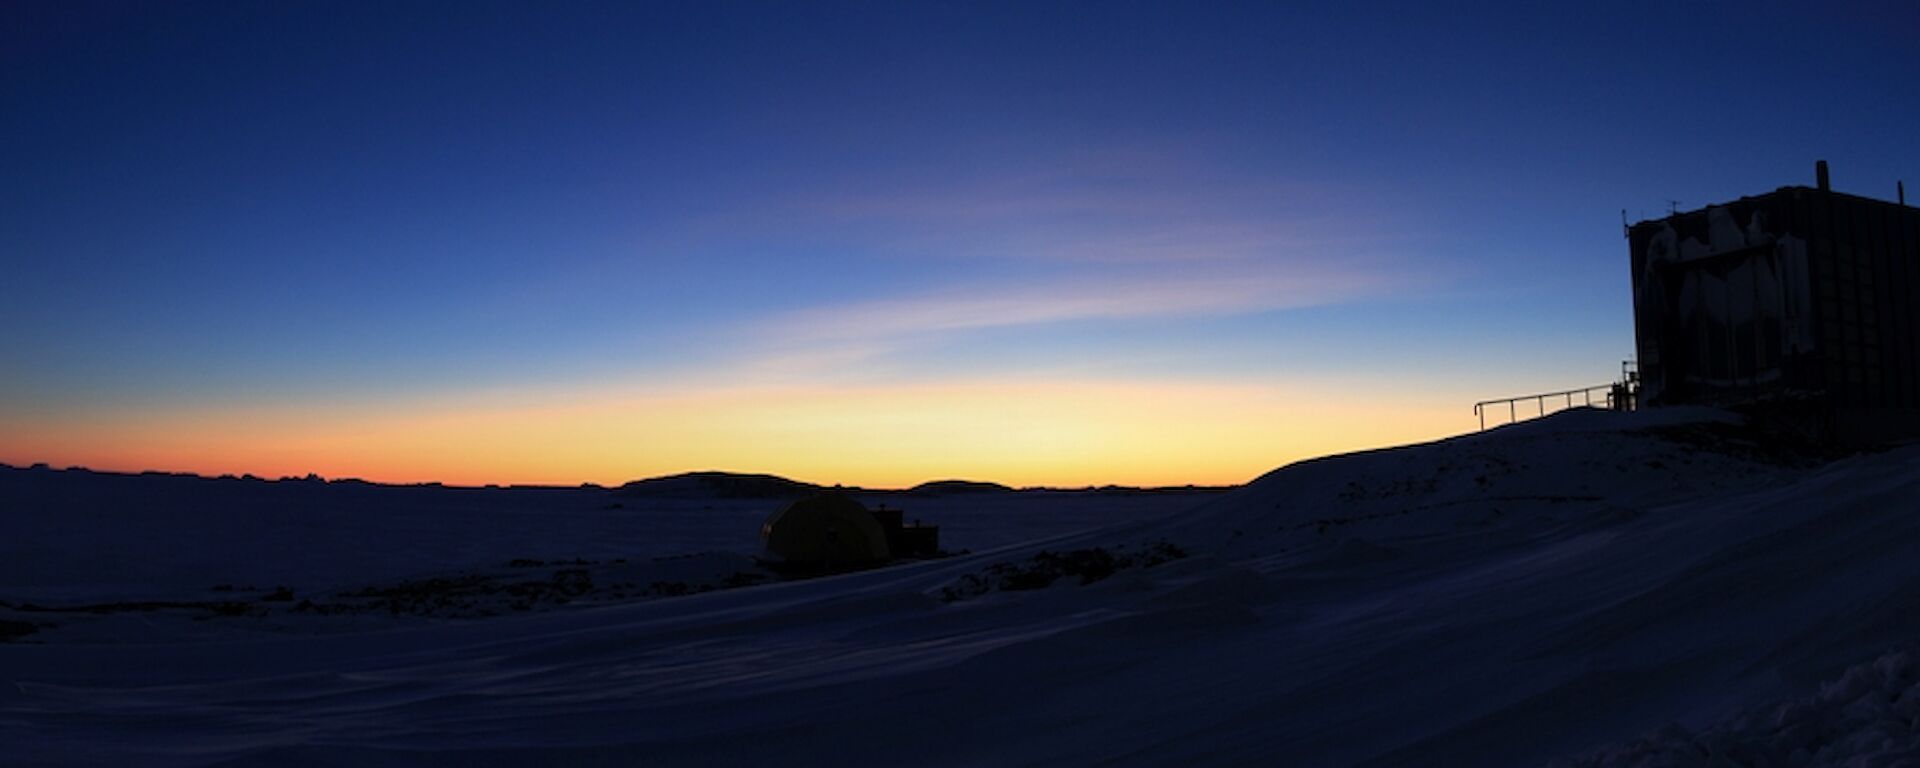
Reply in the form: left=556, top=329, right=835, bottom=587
left=0, top=380, right=1473, bottom=488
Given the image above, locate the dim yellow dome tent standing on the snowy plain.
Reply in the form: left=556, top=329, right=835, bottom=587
left=760, top=493, right=891, bottom=568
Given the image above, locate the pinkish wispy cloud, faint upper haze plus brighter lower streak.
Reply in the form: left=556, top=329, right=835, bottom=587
left=706, top=148, right=1430, bottom=378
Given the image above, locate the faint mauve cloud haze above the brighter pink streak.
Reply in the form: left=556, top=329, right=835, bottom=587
left=793, top=152, right=1407, bottom=270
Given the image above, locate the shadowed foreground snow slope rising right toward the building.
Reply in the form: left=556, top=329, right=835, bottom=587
left=0, top=411, right=1920, bottom=766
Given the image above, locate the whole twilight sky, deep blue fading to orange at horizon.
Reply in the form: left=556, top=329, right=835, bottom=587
left=0, top=2, right=1920, bottom=486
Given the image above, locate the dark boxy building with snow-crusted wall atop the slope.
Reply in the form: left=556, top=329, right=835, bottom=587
left=1628, top=186, right=1920, bottom=440
